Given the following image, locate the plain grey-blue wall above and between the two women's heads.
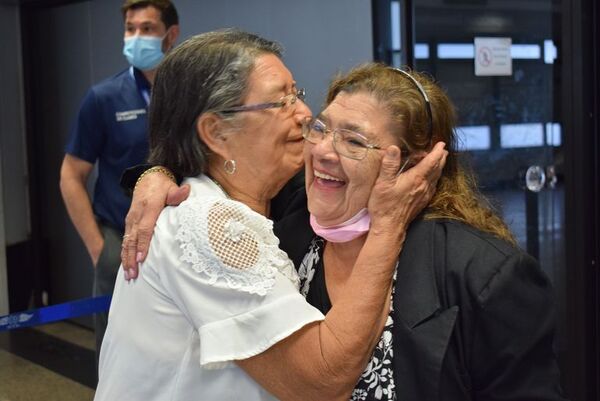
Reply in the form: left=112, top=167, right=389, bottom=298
left=177, top=0, right=373, bottom=112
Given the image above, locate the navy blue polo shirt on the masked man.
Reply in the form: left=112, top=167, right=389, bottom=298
left=65, top=68, right=150, bottom=231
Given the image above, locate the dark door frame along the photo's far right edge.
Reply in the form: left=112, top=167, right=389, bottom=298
left=560, top=0, right=600, bottom=401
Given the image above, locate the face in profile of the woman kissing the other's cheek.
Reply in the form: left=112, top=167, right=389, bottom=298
left=228, top=54, right=311, bottom=200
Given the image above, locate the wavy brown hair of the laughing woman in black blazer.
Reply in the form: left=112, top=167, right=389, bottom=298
left=326, top=63, right=516, bottom=244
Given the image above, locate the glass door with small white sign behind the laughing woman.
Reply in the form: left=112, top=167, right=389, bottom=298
left=388, top=0, right=566, bottom=388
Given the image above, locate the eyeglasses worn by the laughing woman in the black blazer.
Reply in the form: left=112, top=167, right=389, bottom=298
left=302, top=118, right=381, bottom=160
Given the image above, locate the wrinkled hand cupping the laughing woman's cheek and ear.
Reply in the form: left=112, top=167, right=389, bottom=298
left=367, top=142, right=448, bottom=237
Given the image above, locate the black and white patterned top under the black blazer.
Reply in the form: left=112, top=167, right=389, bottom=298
left=298, top=237, right=396, bottom=401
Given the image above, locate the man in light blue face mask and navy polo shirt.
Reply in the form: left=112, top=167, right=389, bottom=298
left=60, top=0, right=179, bottom=362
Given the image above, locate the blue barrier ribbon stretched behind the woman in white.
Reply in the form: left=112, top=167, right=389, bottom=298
left=0, top=295, right=111, bottom=332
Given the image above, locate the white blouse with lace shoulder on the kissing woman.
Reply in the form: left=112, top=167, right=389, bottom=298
left=95, top=176, right=324, bottom=401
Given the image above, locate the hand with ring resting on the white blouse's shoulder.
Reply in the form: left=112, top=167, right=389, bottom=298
left=121, top=173, right=190, bottom=280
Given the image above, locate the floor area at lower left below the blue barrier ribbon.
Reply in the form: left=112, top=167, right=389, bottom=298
left=0, top=322, right=96, bottom=401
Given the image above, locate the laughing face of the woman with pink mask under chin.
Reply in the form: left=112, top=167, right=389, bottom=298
left=304, top=92, right=398, bottom=227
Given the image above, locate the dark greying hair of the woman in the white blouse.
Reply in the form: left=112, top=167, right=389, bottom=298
left=149, top=29, right=283, bottom=177
